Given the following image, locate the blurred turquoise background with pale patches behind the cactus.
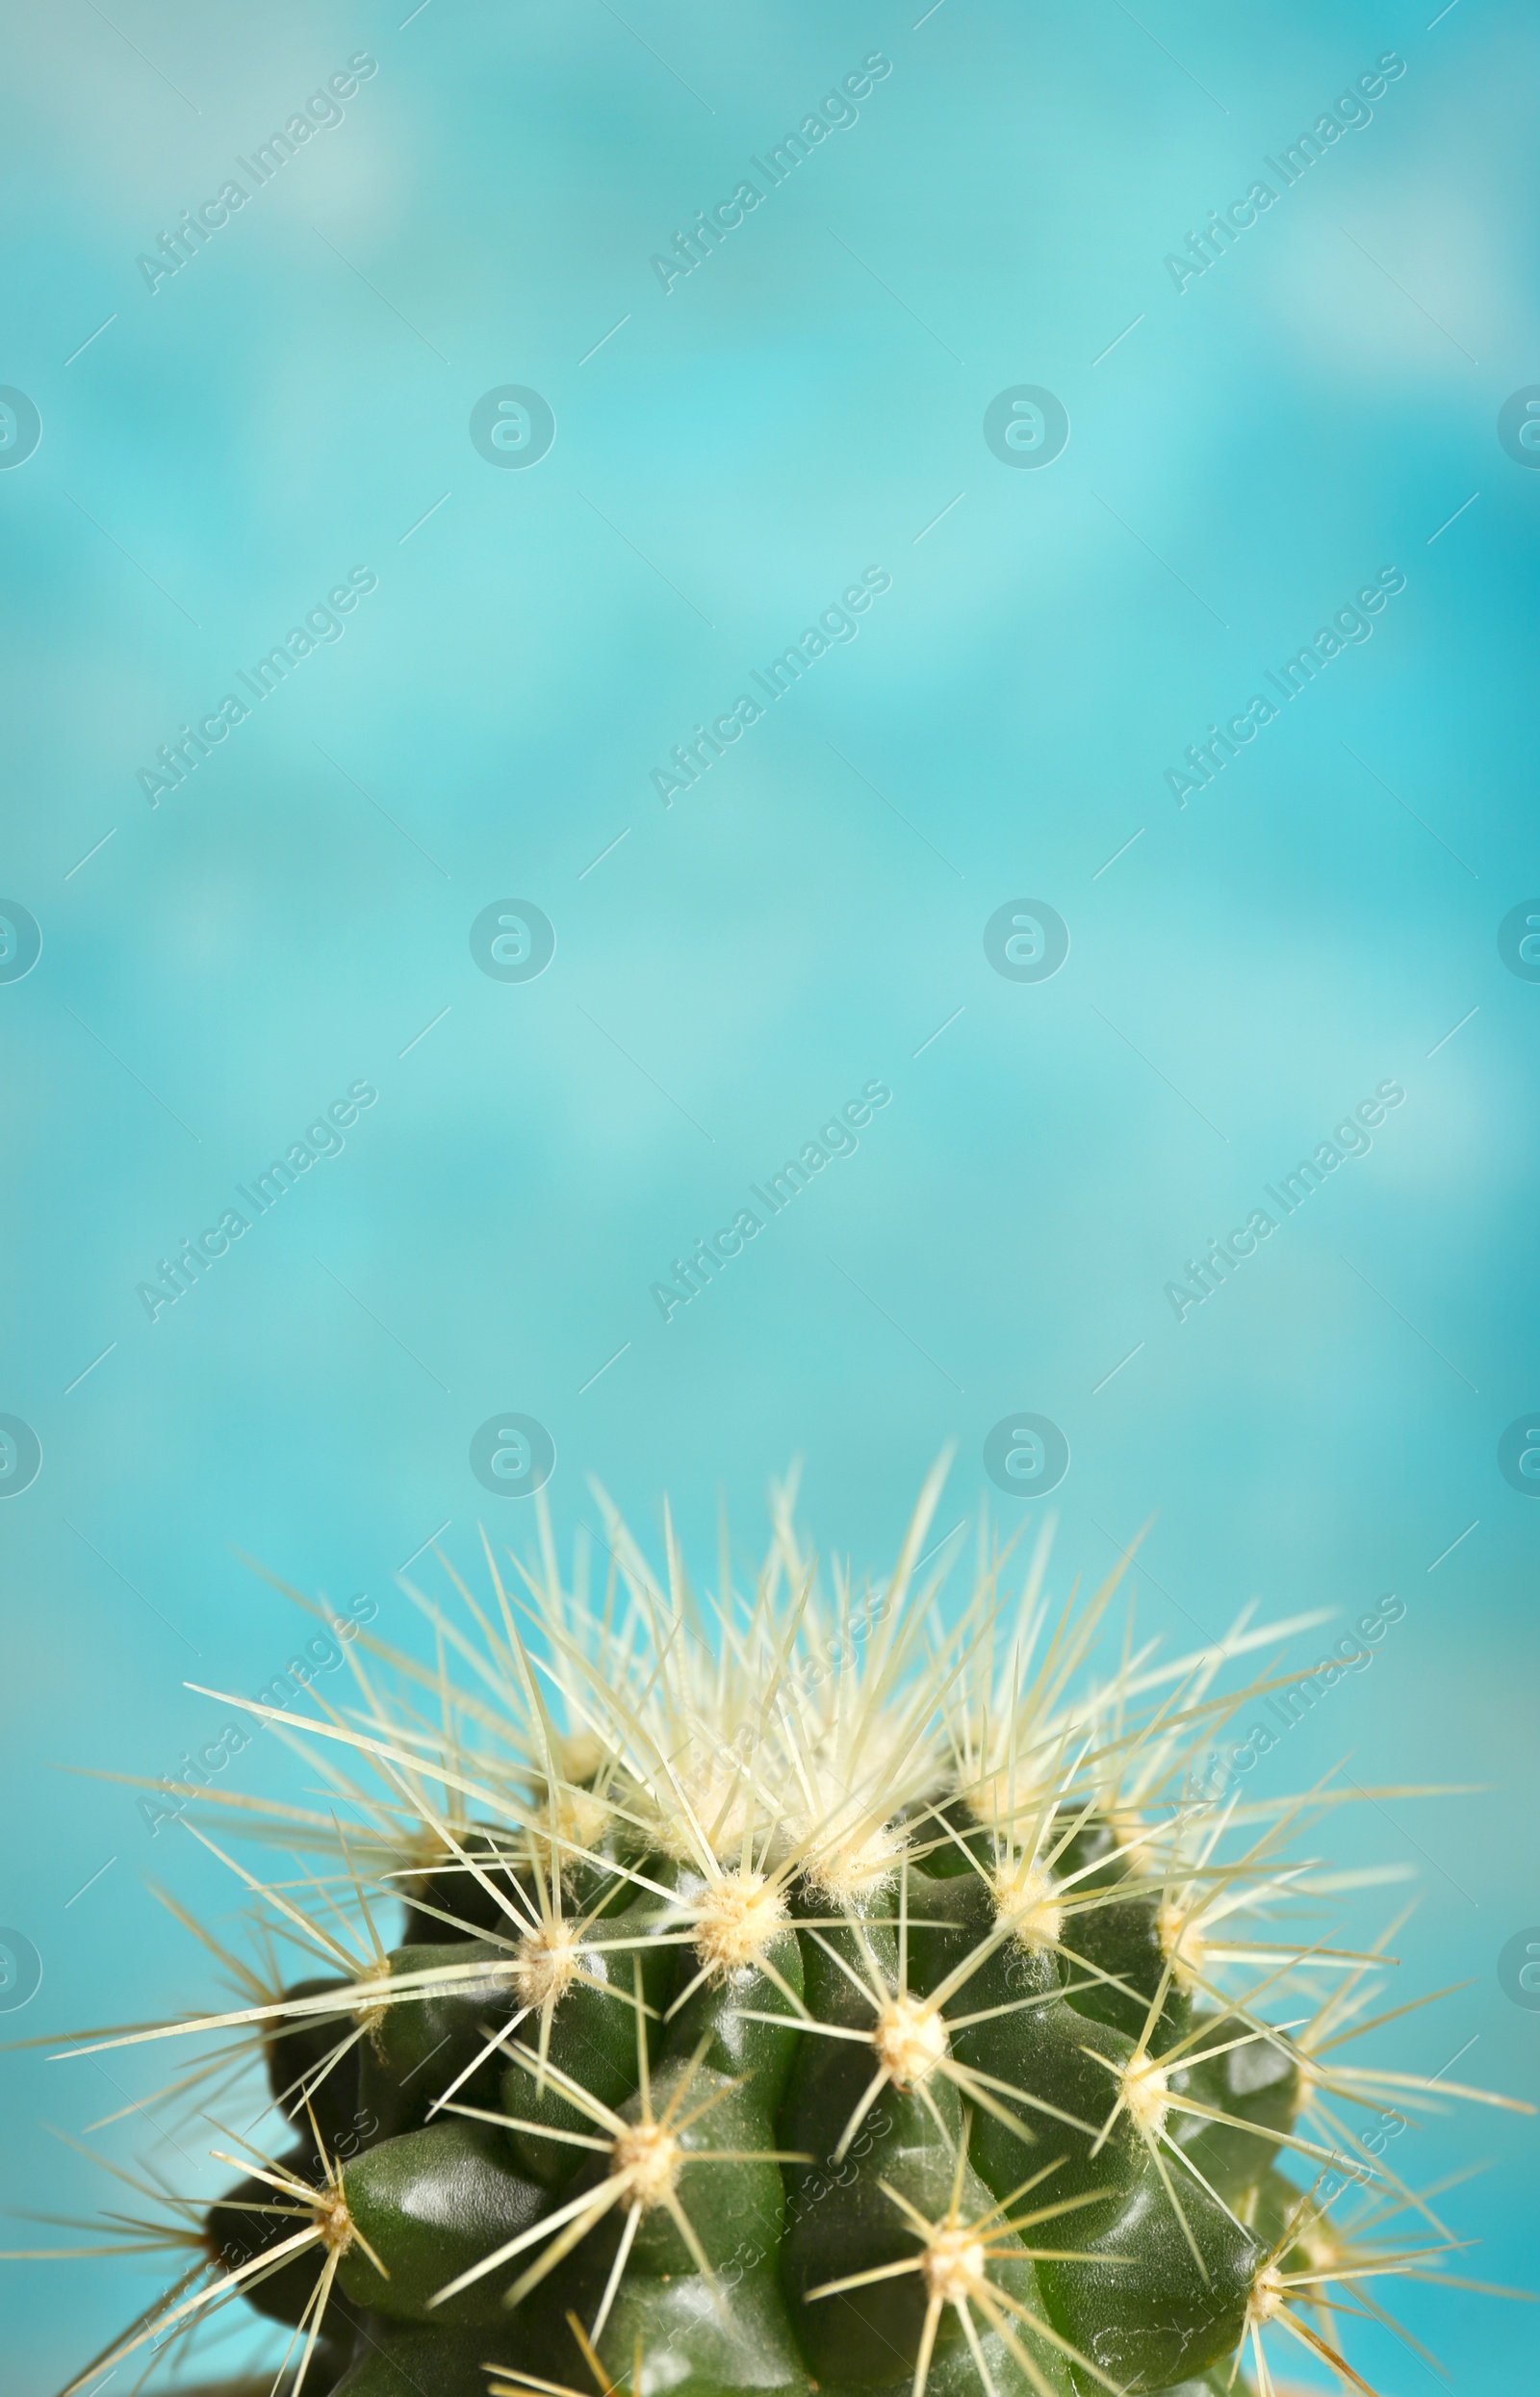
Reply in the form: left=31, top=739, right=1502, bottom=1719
left=0, top=0, right=1540, bottom=2397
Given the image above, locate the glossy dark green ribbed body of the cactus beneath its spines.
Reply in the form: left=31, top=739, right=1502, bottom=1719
left=196, top=1800, right=1298, bottom=2397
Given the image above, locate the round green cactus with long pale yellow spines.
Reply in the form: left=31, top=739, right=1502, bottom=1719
left=20, top=1477, right=1532, bottom=2397
